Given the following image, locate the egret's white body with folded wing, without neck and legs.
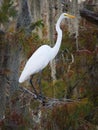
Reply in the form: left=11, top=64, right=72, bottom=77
left=19, top=45, right=50, bottom=82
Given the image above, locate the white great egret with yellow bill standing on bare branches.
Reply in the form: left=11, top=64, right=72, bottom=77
left=19, top=13, right=75, bottom=99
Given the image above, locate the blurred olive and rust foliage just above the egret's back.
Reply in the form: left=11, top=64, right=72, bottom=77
left=16, top=30, right=42, bottom=57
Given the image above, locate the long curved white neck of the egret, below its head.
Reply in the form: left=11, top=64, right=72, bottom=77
left=52, top=17, right=62, bottom=59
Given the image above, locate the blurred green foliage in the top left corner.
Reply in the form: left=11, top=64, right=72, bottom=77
left=0, top=0, right=17, bottom=24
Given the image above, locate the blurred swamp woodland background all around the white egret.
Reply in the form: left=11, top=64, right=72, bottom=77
left=0, top=0, right=98, bottom=130
